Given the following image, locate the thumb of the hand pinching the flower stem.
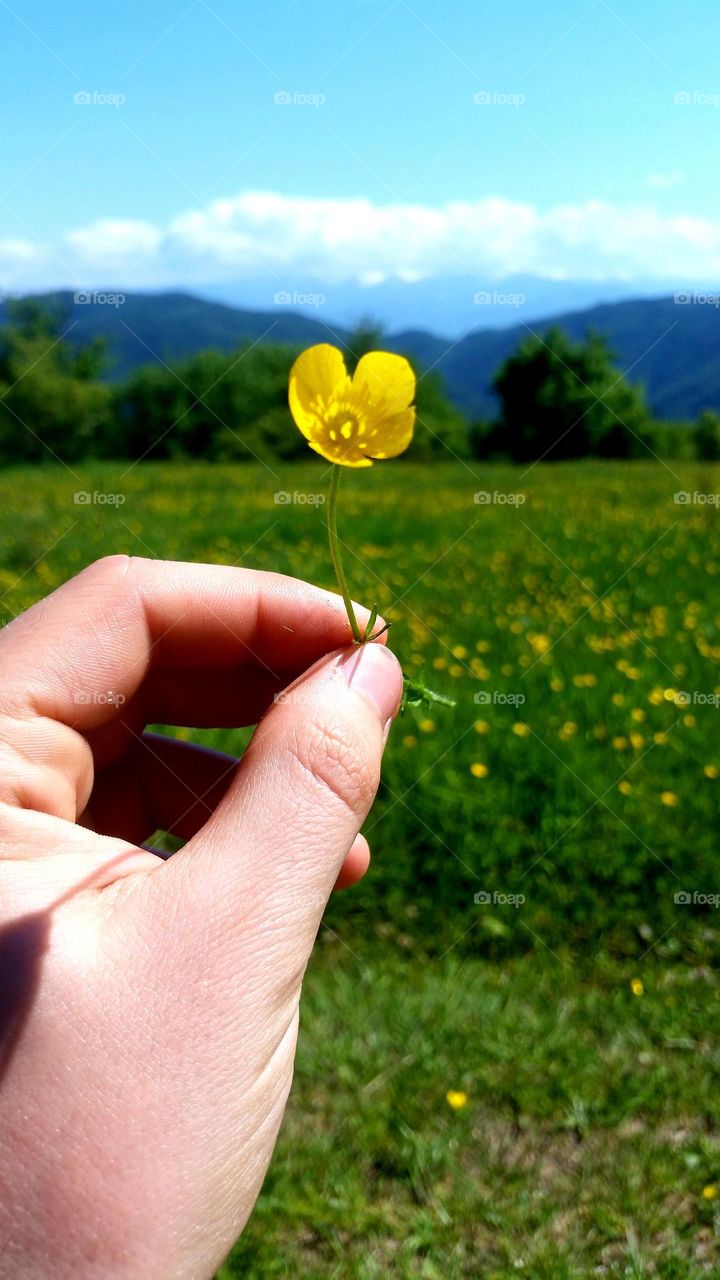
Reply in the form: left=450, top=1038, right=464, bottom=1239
left=160, top=644, right=402, bottom=969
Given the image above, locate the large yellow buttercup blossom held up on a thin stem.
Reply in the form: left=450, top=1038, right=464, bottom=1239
left=288, top=343, right=415, bottom=467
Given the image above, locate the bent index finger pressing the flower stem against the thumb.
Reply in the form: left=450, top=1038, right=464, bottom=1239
left=0, top=556, right=381, bottom=728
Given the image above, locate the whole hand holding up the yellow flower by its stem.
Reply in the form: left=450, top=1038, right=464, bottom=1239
left=0, top=556, right=401, bottom=1280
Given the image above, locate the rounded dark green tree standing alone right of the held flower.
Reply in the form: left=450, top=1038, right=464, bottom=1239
left=493, top=328, right=650, bottom=461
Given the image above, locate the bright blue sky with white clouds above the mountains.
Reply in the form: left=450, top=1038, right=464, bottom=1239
left=0, top=0, right=720, bottom=300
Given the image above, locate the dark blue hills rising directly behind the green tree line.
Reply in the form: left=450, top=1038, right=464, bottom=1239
left=0, top=293, right=720, bottom=419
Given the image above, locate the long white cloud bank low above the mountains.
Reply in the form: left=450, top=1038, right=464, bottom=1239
left=0, top=190, right=720, bottom=288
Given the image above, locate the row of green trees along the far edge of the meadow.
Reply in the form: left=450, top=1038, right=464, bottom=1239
left=0, top=298, right=720, bottom=466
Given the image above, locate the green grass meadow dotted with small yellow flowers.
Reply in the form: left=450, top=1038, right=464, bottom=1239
left=0, top=462, right=720, bottom=1280
